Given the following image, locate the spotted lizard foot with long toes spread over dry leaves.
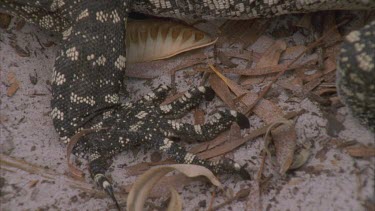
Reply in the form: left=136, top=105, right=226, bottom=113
left=75, top=86, right=249, bottom=174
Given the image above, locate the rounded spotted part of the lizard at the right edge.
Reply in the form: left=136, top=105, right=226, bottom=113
left=337, top=21, right=375, bottom=132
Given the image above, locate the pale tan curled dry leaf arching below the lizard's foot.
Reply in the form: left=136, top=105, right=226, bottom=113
left=127, top=164, right=222, bottom=211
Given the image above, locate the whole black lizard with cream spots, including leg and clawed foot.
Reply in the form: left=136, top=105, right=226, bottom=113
left=0, top=0, right=375, bottom=208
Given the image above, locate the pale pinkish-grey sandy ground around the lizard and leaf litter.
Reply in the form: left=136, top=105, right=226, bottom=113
left=0, top=14, right=375, bottom=211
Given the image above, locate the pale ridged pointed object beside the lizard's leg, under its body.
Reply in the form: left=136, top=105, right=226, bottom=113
left=126, top=20, right=217, bottom=63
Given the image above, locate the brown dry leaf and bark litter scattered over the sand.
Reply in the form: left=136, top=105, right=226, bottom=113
left=2, top=11, right=375, bottom=210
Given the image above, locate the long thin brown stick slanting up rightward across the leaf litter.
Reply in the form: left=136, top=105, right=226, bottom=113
left=245, top=21, right=347, bottom=115
